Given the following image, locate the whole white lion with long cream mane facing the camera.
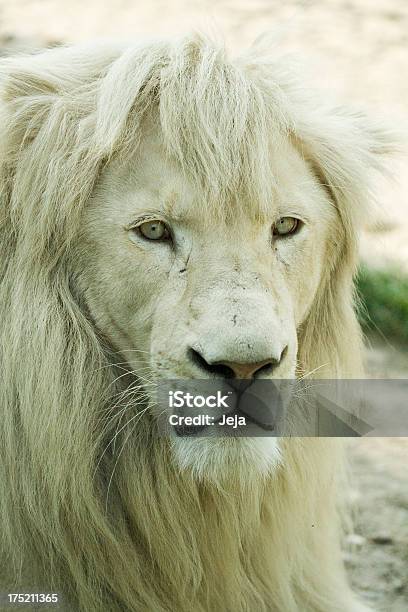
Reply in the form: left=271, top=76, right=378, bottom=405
left=0, top=36, right=393, bottom=612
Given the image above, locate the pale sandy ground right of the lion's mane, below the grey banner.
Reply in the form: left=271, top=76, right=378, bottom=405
left=346, top=438, right=408, bottom=612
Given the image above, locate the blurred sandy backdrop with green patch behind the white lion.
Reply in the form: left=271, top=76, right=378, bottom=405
left=0, top=0, right=408, bottom=612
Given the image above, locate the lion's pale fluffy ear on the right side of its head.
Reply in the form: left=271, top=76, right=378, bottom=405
left=295, top=107, right=403, bottom=228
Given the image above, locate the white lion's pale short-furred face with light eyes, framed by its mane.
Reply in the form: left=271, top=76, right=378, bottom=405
left=80, top=115, right=336, bottom=476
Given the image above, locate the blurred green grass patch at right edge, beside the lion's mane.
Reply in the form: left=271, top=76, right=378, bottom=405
left=357, top=266, right=408, bottom=344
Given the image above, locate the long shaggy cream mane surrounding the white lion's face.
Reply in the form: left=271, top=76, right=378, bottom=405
left=0, top=37, right=392, bottom=612
